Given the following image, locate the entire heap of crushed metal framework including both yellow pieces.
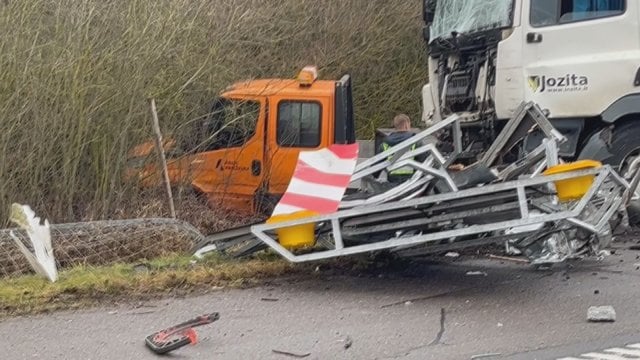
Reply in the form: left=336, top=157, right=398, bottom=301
left=245, top=102, right=639, bottom=264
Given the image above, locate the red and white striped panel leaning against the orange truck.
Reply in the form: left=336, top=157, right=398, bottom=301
left=272, top=143, right=358, bottom=216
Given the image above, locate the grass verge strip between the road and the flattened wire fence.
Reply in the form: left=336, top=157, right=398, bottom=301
left=0, top=255, right=306, bottom=317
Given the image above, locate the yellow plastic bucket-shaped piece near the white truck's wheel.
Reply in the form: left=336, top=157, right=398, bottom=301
left=543, top=160, right=602, bottom=202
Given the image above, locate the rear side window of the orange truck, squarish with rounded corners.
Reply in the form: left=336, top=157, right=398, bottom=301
left=277, top=101, right=321, bottom=148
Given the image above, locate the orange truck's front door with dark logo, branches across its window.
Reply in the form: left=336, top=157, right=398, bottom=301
left=191, top=97, right=266, bottom=211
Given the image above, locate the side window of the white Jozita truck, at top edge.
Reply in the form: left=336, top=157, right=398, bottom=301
left=530, top=0, right=625, bottom=27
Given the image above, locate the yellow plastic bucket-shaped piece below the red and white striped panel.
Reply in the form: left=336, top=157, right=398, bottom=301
left=266, top=210, right=318, bottom=250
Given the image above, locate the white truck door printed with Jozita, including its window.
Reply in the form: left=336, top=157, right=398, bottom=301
left=522, top=0, right=640, bottom=119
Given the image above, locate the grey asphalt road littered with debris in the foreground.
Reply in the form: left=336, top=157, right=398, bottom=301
left=0, top=243, right=640, bottom=360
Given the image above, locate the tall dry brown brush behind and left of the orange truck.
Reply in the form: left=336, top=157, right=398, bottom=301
left=0, top=0, right=426, bottom=227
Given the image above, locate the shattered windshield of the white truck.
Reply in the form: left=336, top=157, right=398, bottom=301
left=431, top=0, right=513, bottom=39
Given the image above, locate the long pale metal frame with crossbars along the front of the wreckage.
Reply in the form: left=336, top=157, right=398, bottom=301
left=251, top=166, right=624, bottom=262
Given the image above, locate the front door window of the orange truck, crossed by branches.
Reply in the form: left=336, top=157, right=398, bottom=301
left=200, top=99, right=260, bottom=151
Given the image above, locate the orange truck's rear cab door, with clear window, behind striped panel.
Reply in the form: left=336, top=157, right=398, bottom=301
left=265, top=96, right=333, bottom=200
